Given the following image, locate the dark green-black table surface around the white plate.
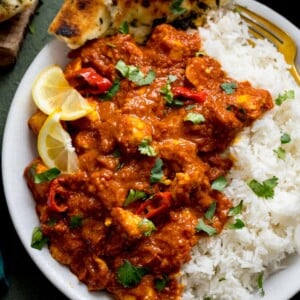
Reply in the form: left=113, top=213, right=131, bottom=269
left=0, top=0, right=300, bottom=300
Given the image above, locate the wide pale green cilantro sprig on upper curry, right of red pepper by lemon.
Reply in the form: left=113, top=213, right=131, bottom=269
left=116, top=60, right=156, bottom=86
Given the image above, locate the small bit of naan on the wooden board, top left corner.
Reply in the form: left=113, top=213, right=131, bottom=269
left=0, top=0, right=36, bottom=22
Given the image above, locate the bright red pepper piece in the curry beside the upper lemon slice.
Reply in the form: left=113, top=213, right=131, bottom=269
left=68, top=67, right=112, bottom=95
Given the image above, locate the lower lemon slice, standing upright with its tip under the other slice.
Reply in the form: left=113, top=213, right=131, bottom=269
left=37, top=112, right=78, bottom=173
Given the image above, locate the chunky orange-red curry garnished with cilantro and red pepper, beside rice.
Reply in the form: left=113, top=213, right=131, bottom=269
left=25, top=24, right=273, bottom=300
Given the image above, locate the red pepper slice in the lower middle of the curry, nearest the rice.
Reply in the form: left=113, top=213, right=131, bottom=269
left=136, top=192, right=172, bottom=219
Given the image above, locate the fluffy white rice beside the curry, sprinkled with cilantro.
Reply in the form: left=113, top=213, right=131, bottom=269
left=182, top=10, right=300, bottom=300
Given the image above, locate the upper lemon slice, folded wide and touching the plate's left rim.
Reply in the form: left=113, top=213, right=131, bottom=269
left=32, top=65, right=92, bottom=121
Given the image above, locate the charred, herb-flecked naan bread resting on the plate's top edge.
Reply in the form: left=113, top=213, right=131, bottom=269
left=48, top=0, right=230, bottom=49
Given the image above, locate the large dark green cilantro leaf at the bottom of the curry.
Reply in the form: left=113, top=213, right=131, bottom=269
left=117, top=260, right=148, bottom=288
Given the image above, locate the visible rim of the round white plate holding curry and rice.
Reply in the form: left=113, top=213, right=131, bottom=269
left=2, top=0, right=300, bottom=300
